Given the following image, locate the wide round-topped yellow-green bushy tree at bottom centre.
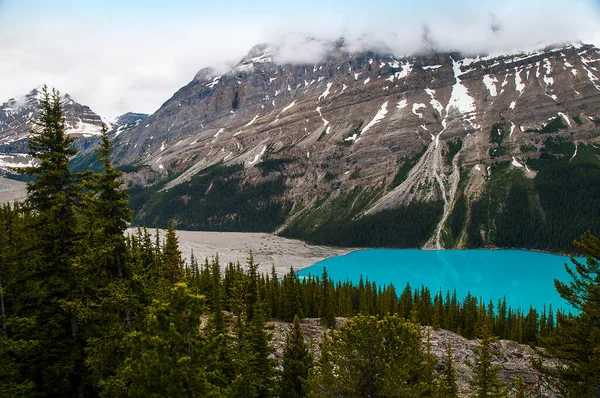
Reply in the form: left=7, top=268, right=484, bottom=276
left=307, top=316, right=435, bottom=398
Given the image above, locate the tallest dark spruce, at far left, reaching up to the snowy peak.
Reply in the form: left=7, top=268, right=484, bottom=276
left=21, top=86, right=87, bottom=396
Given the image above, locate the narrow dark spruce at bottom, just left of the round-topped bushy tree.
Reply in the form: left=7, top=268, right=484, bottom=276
left=281, top=316, right=313, bottom=398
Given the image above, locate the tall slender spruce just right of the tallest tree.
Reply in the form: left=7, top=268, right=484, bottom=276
left=79, top=125, right=135, bottom=392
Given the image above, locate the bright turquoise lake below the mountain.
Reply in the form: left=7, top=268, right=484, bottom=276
left=298, top=249, right=571, bottom=311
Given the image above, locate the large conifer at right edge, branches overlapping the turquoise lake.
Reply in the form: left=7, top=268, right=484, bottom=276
left=538, top=232, right=600, bottom=398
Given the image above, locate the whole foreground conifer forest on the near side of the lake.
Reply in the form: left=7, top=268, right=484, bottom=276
left=0, top=89, right=600, bottom=397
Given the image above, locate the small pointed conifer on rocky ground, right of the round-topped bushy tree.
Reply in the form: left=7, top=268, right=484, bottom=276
left=467, top=325, right=508, bottom=398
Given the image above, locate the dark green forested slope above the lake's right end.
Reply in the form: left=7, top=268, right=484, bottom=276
left=467, top=143, right=600, bottom=253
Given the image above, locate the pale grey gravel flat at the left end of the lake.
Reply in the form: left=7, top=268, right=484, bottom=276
left=128, top=228, right=353, bottom=276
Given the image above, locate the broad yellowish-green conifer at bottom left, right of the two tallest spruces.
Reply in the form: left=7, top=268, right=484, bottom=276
left=112, top=282, right=220, bottom=397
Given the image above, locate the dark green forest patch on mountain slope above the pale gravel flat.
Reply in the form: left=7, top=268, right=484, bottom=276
left=132, top=165, right=289, bottom=232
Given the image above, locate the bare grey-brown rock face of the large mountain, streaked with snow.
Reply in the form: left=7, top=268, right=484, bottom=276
left=115, top=41, right=600, bottom=247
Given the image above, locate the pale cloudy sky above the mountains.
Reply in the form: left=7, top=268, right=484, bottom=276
left=0, top=0, right=600, bottom=119
